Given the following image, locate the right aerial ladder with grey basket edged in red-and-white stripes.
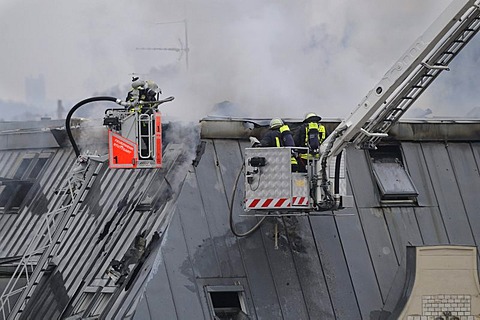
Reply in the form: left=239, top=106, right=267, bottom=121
left=244, top=0, right=480, bottom=216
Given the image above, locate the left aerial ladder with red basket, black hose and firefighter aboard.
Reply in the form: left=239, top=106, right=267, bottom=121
left=0, top=78, right=174, bottom=319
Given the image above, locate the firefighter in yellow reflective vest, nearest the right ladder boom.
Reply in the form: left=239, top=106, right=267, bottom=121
left=294, top=112, right=326, bottom=172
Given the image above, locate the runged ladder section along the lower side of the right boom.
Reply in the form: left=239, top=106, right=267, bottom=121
left=353, top=2, right=480, bottom=148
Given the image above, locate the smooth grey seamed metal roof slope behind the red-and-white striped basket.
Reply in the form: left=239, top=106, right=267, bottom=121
left=135, top=121, right=480, bottom=319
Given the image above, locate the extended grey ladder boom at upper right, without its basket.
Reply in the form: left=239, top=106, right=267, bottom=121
left=321, top=0, right=480, bottom=157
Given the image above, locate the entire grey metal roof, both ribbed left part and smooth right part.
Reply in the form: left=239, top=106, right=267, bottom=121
left=0, top=120, right=480, bottom=320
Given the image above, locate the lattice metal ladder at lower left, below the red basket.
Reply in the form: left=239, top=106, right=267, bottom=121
left=0, top=155, right=102, bottom=319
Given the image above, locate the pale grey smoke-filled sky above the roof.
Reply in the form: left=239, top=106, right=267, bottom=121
left=0, top=0, right=480, bottom=121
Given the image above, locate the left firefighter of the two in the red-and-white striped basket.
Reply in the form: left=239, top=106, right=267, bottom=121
left=252, top=118, right=297, bottom=172
